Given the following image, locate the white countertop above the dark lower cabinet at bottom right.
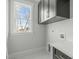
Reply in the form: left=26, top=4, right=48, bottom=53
left=50, top=40, right=73, bottom=58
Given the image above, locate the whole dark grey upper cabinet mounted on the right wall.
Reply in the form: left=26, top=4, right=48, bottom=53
left=38, top=0, right=70, bottom=24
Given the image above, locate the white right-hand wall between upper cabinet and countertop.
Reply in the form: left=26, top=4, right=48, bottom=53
left=47, top=19, right=73, bottom=41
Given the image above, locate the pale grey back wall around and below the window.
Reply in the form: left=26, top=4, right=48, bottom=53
left=8, top=0, right=46, bottom=54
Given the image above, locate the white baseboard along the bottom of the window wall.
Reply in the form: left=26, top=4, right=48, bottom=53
left=9, top=47, right=46, bottom=59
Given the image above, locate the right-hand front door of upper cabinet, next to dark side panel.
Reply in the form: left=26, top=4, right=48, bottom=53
left=44, top=0, right=56, bottom=20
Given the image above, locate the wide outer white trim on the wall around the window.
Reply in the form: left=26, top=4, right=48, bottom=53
left=11, top=1, right=34, bottom=33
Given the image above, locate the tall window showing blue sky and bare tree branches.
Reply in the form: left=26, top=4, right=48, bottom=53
left=15, top=2, right=32, bottom=32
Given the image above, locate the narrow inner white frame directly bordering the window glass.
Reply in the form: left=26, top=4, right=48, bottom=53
left=14, top=1, right=33, bottom=33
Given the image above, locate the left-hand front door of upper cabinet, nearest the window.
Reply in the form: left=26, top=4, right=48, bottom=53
left=38, top=0, right=49, bottom=23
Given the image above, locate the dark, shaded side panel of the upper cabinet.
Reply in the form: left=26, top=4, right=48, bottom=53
left=56, top=0, right=70, bottom=18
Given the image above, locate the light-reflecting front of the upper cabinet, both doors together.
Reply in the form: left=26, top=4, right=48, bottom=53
left=38, top=0, right=56, bottom=22
